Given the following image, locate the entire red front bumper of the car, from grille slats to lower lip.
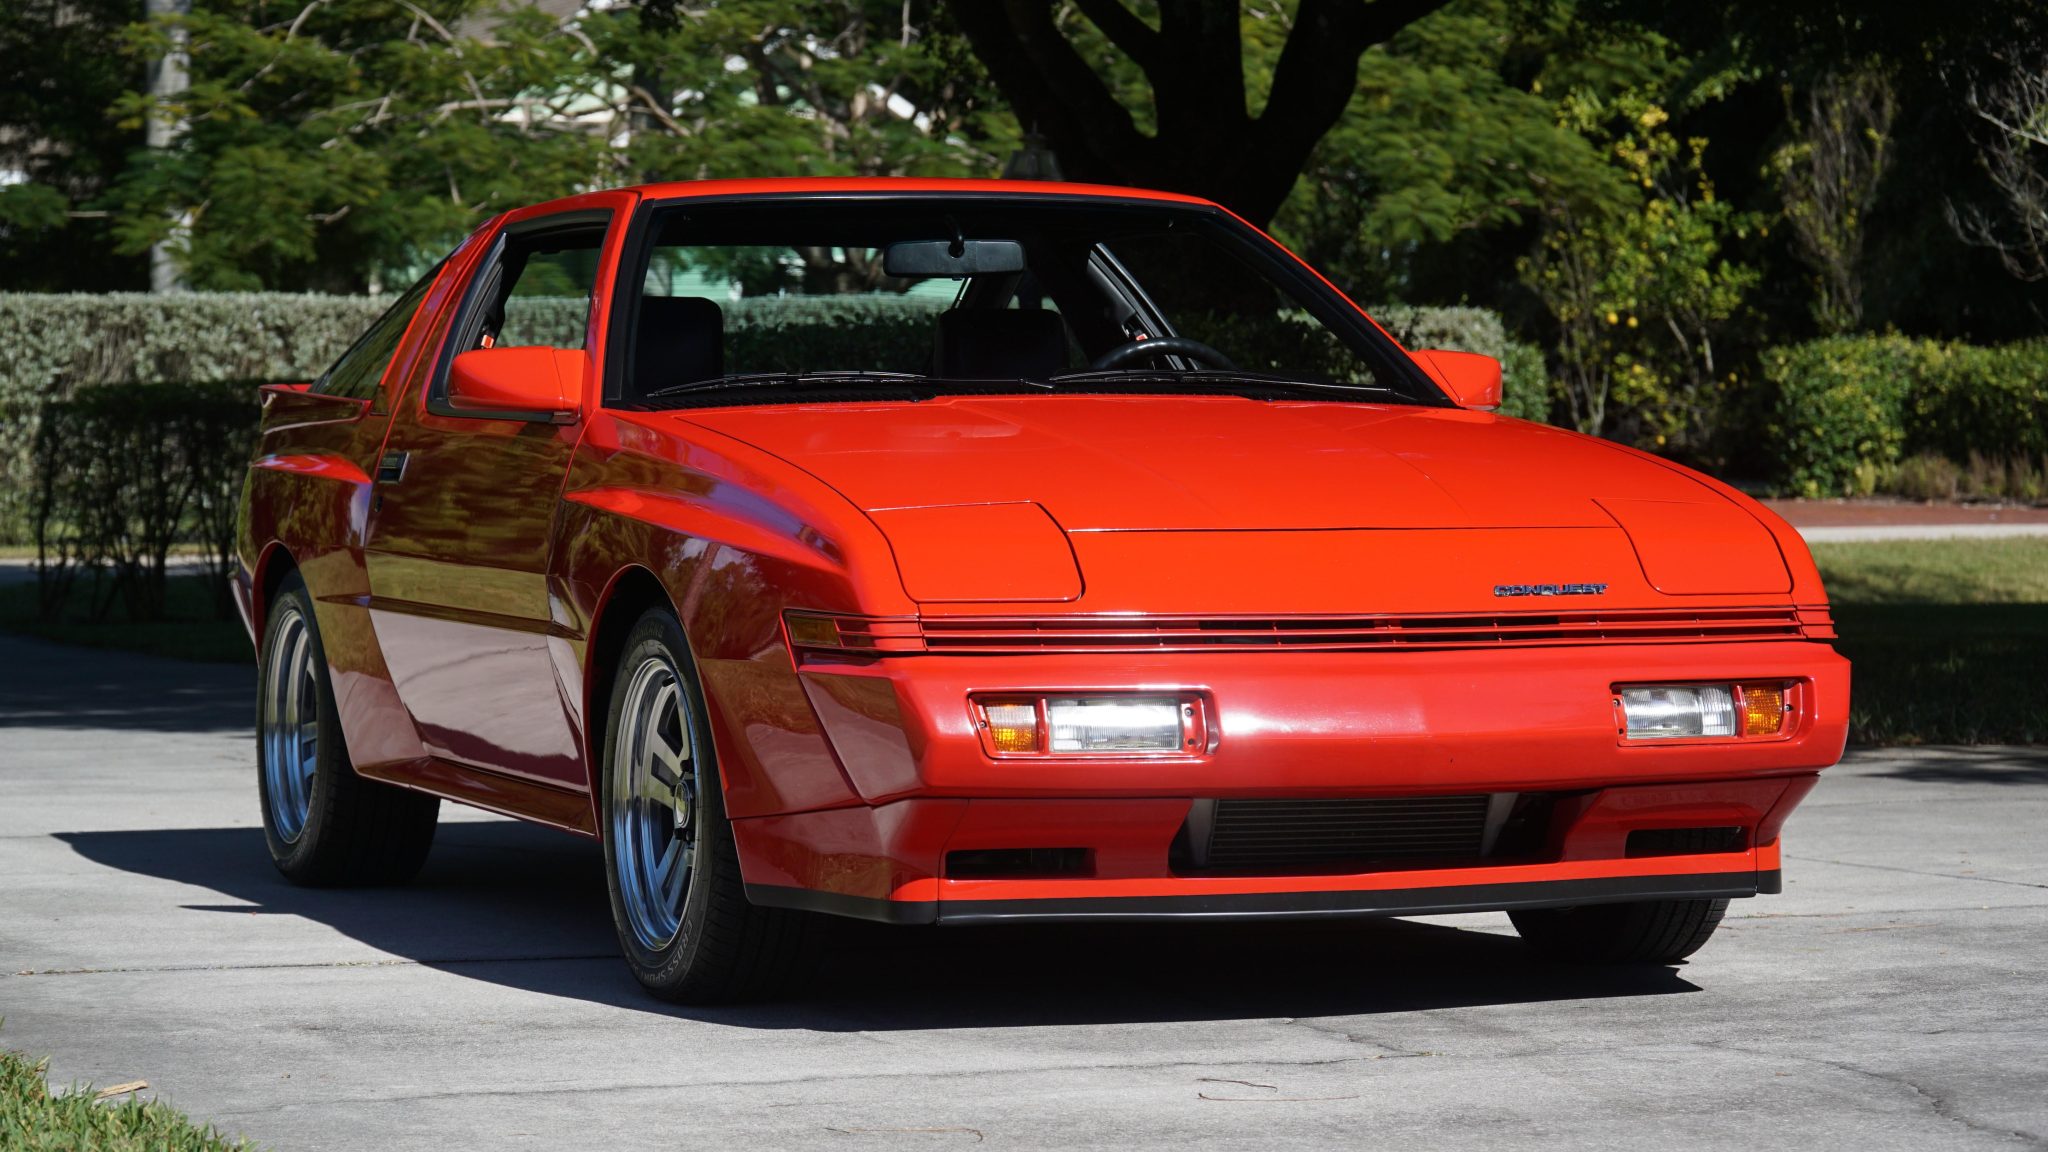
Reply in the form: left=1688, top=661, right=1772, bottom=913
left=733, top=642, right=1849, bottom=922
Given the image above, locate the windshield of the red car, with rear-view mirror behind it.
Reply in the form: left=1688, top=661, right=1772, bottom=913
left=616, top=195, right=1444, bottom=406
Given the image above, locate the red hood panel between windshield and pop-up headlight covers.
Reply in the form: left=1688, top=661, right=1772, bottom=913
left=688, top=396, right=1720, bottom=531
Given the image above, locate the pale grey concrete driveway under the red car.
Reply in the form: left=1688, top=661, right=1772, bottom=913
left=0, top=640, right=2048, bottom=1152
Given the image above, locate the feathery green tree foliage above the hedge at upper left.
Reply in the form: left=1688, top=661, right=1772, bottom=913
left=111, top=0, right=606, bottom=291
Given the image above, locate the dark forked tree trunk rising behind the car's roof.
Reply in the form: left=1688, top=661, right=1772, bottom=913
left=950, top=0, right=1446, bottom=223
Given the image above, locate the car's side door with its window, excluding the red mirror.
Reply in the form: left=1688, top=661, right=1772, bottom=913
left=365, top=193, right=635, bottom=789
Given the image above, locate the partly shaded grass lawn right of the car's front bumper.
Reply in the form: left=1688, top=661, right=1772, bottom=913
left=1812, top=537, right=2048, bottom=744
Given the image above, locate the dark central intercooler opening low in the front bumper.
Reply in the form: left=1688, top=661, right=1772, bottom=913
left=1206, top=793, right=1489, bottom=871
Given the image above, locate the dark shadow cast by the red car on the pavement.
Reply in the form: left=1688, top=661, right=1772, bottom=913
left=59, top=822, right=1698, bottom=1031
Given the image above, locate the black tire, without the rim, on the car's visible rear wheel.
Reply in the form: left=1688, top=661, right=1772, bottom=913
left=256, top=572, right=440, bottom=888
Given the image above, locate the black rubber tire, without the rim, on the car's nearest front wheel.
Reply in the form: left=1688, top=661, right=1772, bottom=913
left=600, top=609, right=817, bottom=1004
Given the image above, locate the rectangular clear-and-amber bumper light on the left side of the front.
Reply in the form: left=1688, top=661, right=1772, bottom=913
left=973, top=693, right=1210, bottom=756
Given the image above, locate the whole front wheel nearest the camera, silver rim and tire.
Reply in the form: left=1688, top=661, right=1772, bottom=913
left=602, top=609, right=813, bottom=1004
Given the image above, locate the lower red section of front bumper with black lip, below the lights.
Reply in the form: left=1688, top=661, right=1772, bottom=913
left=735, top=773, right=1819, bottom=924
